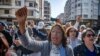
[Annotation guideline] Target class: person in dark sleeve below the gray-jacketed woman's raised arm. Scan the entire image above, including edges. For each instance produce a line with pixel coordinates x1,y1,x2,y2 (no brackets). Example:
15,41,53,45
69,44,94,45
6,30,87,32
14,39,41,56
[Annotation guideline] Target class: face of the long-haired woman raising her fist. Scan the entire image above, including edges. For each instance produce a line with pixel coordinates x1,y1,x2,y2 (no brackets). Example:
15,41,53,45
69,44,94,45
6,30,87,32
51,26,62,45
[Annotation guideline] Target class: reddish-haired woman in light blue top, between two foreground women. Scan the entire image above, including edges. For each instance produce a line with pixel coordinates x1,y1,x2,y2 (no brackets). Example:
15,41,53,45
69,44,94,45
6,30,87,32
66,26,81,49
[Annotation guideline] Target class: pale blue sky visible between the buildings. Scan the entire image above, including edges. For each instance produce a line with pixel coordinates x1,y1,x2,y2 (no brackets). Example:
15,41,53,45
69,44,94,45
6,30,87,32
48,0,67,18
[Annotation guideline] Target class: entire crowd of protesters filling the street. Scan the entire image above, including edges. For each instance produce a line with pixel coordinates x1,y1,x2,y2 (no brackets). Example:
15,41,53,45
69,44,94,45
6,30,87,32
0,7,100,56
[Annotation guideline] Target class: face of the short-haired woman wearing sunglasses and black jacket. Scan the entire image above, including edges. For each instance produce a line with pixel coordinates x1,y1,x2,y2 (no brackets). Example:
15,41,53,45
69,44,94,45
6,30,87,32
83,31,95,44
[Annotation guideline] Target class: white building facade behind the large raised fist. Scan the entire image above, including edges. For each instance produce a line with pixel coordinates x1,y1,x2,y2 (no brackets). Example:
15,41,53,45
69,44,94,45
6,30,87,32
0,0,39,21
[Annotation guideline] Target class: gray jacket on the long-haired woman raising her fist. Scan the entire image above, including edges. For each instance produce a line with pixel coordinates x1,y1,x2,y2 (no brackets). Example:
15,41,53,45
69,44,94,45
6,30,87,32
19,30,73,56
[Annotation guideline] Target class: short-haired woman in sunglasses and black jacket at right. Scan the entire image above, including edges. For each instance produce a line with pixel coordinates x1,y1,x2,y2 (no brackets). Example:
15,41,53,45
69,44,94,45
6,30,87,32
74,28,100,56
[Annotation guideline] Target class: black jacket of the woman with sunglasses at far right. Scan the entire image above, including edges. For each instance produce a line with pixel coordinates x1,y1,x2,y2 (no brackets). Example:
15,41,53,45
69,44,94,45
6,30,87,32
74,44,100,56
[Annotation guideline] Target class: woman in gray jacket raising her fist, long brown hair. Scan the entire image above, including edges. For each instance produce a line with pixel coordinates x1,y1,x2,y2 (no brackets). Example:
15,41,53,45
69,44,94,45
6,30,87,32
16,7,73,56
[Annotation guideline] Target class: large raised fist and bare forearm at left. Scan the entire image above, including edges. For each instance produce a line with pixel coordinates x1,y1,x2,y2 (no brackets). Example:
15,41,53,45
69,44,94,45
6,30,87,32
15,6,27,33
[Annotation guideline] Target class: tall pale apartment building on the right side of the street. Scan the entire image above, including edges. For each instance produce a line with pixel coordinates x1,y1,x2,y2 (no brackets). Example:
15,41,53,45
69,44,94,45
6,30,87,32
64,0,98,26
